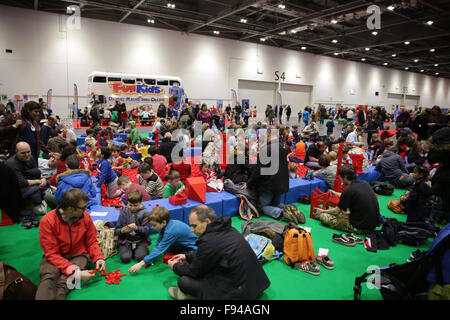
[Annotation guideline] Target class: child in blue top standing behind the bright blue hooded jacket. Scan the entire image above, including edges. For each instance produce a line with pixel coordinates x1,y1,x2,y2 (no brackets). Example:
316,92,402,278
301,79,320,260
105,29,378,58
97,147,122,199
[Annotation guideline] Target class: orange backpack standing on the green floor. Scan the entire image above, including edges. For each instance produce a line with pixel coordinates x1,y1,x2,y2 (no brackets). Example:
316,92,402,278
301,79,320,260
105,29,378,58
283,228,316,267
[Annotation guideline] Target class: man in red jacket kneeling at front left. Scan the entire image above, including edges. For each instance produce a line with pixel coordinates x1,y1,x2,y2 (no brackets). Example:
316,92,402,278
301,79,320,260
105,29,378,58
36,188,106,300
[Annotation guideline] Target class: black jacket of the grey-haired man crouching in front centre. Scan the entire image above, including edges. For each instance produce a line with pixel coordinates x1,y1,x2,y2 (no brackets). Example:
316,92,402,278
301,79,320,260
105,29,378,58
173,216,270,300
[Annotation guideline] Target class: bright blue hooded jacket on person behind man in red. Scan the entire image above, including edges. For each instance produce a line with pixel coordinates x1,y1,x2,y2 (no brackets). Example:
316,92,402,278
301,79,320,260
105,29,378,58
55,169,100,208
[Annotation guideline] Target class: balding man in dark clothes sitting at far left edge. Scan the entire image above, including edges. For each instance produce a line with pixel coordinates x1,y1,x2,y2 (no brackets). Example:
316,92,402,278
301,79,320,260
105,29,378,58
5,141,50,229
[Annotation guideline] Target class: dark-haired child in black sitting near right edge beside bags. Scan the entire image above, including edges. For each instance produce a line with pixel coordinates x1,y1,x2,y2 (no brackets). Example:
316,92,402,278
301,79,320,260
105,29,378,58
401,166,431,222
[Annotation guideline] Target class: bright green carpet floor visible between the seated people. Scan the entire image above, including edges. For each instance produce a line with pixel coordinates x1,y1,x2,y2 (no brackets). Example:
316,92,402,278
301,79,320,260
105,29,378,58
0,190,438,300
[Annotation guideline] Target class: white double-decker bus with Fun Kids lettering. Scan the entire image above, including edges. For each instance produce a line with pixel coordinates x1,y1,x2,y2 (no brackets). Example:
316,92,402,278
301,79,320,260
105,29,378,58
88,72,184,109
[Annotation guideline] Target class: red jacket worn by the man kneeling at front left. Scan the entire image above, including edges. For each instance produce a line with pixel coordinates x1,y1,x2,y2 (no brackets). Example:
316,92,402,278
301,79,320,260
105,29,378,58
39,208,103,276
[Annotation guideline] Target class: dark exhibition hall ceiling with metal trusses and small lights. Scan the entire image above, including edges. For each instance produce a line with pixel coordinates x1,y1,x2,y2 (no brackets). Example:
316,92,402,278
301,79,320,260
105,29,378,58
2,0,450,78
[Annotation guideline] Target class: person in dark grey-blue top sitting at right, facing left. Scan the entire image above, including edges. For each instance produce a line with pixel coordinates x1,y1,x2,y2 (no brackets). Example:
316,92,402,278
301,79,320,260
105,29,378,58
375,141,414,189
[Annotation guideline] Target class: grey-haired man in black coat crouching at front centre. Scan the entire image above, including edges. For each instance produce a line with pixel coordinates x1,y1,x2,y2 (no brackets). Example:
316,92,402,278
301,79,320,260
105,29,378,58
168,205,270,300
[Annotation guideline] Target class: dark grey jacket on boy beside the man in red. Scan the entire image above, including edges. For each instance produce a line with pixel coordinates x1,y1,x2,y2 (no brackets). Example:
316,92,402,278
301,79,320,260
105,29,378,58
114,206,152,245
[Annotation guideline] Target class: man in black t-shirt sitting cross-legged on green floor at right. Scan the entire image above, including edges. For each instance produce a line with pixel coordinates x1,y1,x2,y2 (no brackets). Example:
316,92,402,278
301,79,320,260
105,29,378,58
314,165,380,234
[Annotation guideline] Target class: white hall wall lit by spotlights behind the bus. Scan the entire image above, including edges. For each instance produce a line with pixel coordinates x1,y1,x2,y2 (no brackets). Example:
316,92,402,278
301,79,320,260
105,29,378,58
0,6,450,115
